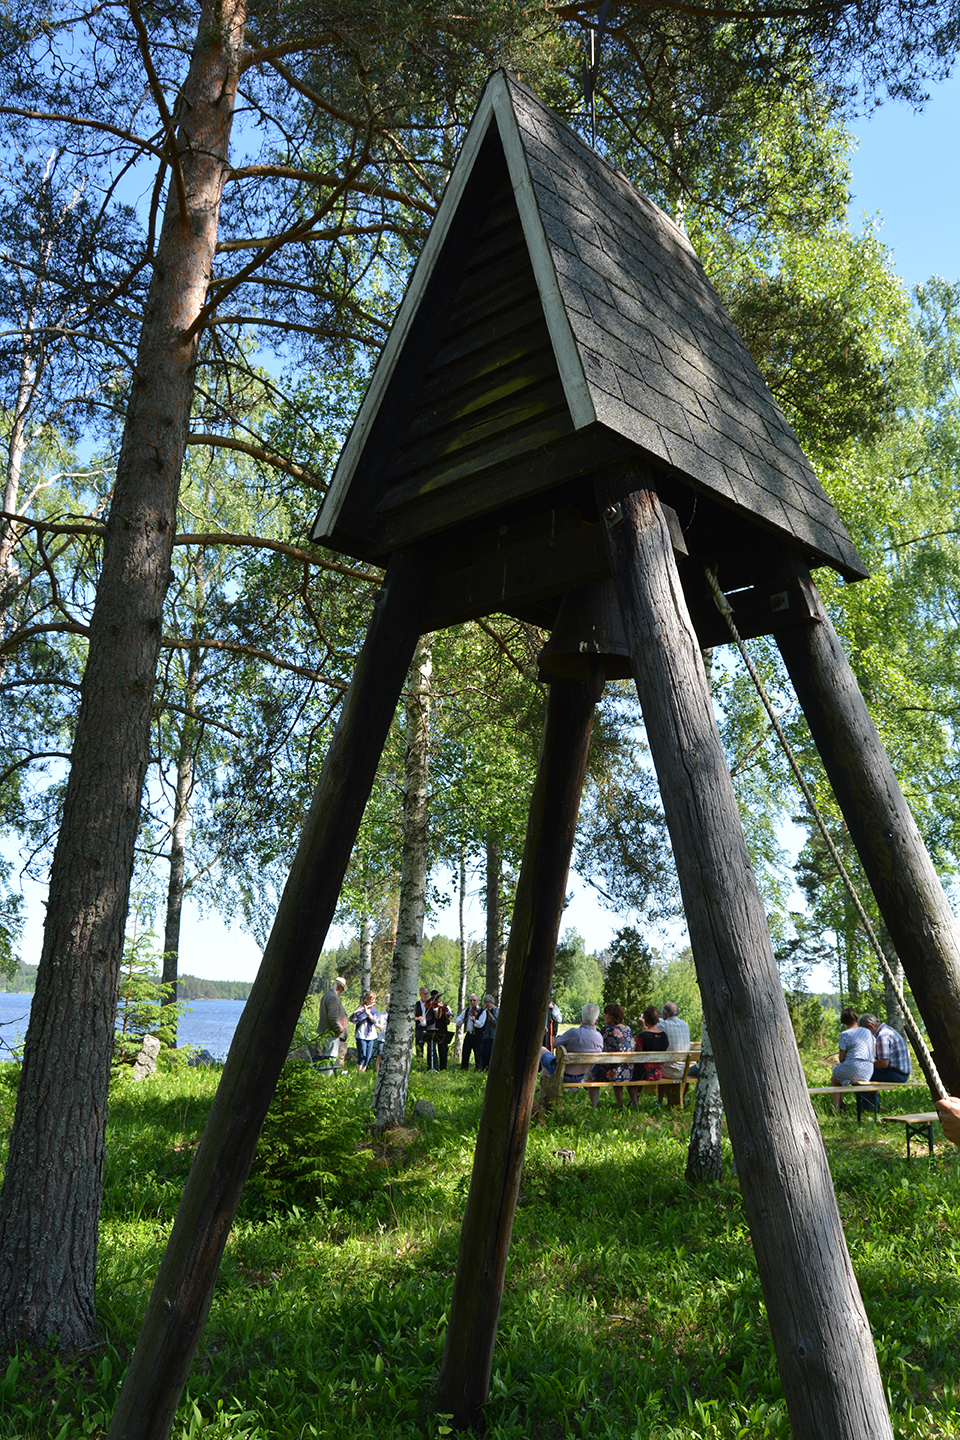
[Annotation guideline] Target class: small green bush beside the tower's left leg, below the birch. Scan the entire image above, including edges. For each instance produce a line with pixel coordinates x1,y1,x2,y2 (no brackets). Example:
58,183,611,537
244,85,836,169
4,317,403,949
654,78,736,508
243,1060,371,1218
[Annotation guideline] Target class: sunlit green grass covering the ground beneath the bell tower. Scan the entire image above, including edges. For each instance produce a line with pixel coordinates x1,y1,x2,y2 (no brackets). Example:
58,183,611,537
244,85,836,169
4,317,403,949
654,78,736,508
0,1070,960,1440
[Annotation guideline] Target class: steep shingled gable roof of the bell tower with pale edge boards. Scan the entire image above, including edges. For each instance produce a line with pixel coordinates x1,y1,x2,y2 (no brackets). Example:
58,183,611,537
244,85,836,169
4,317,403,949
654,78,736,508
312,72,866,579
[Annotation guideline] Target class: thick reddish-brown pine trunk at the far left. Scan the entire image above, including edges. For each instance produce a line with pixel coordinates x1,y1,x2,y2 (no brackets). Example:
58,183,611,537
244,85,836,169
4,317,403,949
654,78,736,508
0,0,245,1351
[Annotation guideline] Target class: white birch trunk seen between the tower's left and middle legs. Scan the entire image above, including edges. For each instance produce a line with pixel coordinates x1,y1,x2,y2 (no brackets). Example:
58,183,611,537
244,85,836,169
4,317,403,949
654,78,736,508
373,635,433,1130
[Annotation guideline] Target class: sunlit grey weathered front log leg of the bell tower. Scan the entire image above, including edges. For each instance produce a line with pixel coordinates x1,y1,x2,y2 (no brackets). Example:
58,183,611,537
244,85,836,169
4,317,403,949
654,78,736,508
596,465,891,1440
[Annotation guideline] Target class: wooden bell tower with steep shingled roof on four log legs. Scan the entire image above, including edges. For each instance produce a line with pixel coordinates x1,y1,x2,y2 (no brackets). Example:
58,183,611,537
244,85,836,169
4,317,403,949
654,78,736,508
109,72,960,1440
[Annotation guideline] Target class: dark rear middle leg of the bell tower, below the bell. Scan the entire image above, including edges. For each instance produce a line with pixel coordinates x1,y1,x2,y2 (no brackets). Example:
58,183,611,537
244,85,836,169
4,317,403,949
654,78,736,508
436,680,596,1420
